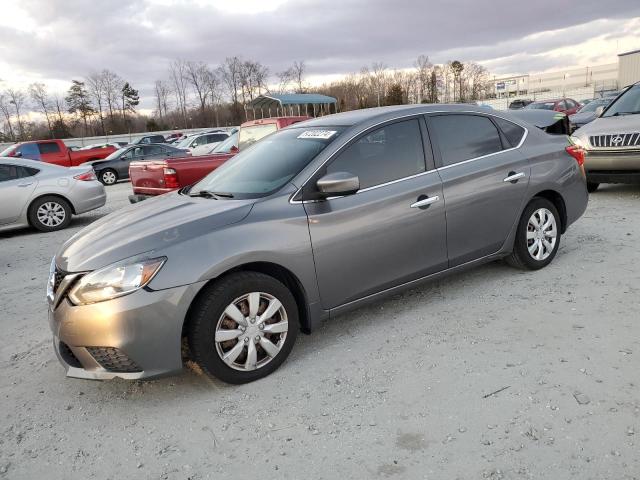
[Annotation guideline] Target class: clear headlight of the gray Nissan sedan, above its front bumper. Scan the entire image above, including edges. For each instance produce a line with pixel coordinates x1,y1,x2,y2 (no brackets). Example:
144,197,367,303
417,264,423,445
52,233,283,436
69,257,167,305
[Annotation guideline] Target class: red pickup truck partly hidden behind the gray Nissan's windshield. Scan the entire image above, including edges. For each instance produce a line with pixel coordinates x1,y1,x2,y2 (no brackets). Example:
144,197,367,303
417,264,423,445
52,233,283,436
129,117,310,203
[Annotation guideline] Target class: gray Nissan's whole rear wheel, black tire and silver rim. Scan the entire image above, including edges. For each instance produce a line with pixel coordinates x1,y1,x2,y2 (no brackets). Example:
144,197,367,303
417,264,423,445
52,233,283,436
506,197,562,270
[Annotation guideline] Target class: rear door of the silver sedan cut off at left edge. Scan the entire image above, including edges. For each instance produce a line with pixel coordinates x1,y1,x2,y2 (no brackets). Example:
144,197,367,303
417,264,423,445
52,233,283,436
0,162,38,225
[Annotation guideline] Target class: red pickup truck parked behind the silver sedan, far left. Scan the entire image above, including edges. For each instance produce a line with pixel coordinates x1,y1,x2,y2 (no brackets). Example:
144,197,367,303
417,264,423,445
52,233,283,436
0,140,116,167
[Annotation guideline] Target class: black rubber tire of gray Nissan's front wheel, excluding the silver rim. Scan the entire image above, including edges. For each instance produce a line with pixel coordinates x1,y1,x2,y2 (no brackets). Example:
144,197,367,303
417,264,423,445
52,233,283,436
187,272,300,384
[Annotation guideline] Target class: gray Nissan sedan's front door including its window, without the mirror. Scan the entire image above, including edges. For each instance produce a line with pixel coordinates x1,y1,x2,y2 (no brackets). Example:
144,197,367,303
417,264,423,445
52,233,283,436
304,118,447,309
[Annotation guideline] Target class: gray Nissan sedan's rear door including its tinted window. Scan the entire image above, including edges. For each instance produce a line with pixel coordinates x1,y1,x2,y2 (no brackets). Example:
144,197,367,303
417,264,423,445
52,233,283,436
427,113,531,267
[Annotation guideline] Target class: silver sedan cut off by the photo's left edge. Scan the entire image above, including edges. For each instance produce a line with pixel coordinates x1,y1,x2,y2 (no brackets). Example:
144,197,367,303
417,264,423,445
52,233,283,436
0,157,107,232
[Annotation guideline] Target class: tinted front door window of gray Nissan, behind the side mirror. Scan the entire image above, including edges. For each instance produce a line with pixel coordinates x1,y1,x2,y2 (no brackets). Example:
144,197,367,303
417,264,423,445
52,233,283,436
327,119,426,188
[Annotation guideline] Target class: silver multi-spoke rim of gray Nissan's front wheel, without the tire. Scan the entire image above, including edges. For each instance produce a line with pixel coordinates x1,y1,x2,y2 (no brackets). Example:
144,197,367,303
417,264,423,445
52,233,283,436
215,292,289,371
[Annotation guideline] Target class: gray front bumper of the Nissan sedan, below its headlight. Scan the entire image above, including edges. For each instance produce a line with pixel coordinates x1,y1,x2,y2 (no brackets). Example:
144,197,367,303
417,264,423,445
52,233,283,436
49,283,203,380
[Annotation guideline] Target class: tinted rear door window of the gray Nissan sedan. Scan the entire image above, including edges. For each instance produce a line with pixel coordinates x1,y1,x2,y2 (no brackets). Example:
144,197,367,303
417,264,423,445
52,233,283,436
429,115,502,167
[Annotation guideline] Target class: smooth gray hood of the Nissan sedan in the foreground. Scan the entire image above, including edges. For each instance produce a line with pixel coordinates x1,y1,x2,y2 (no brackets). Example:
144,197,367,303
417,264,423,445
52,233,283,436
56,192,255,272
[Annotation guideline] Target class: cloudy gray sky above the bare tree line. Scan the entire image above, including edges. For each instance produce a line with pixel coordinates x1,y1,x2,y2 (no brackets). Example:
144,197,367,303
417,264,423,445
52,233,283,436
0,0,640,106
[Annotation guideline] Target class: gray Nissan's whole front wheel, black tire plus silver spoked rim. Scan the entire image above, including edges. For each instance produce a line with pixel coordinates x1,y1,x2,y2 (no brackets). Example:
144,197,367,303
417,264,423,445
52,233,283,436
186,272,300,384
